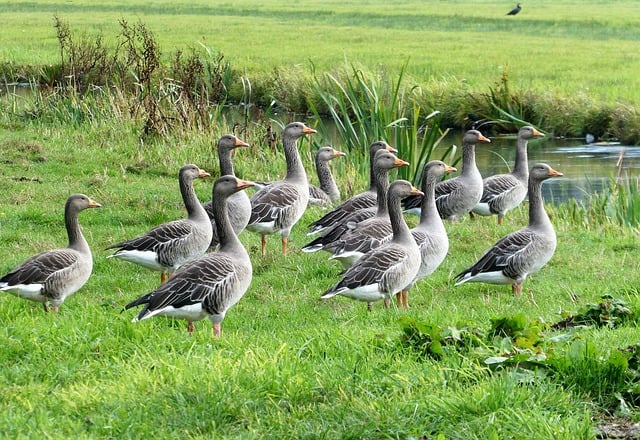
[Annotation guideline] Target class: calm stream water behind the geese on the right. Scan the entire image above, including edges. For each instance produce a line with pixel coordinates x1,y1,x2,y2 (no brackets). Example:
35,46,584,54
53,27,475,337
458,134,640,204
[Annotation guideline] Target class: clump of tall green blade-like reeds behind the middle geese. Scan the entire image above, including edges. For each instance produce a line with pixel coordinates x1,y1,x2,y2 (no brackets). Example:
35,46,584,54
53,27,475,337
310,66,455,184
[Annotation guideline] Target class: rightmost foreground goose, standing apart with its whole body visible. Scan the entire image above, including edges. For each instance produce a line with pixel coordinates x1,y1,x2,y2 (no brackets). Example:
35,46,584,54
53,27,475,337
455,163,562,295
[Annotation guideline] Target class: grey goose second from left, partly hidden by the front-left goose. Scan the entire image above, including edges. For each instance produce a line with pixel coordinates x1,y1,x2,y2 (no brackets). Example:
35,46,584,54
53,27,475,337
107,164,213,283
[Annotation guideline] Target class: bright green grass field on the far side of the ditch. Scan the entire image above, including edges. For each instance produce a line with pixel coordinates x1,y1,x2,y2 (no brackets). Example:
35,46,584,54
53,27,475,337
0,0,640,104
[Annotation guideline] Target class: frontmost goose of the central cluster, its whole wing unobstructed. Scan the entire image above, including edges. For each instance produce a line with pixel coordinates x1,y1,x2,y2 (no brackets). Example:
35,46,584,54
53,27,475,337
321,180,422,306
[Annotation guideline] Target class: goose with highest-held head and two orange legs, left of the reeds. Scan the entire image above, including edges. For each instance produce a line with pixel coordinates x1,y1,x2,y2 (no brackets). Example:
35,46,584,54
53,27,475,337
247,122,316,256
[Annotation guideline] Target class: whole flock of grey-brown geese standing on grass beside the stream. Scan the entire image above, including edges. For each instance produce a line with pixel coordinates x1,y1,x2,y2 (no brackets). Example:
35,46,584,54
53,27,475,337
0,122,562,336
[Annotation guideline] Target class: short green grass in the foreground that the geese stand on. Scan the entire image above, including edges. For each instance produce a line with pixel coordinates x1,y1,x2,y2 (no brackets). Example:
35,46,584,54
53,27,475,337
0,118,640,439
